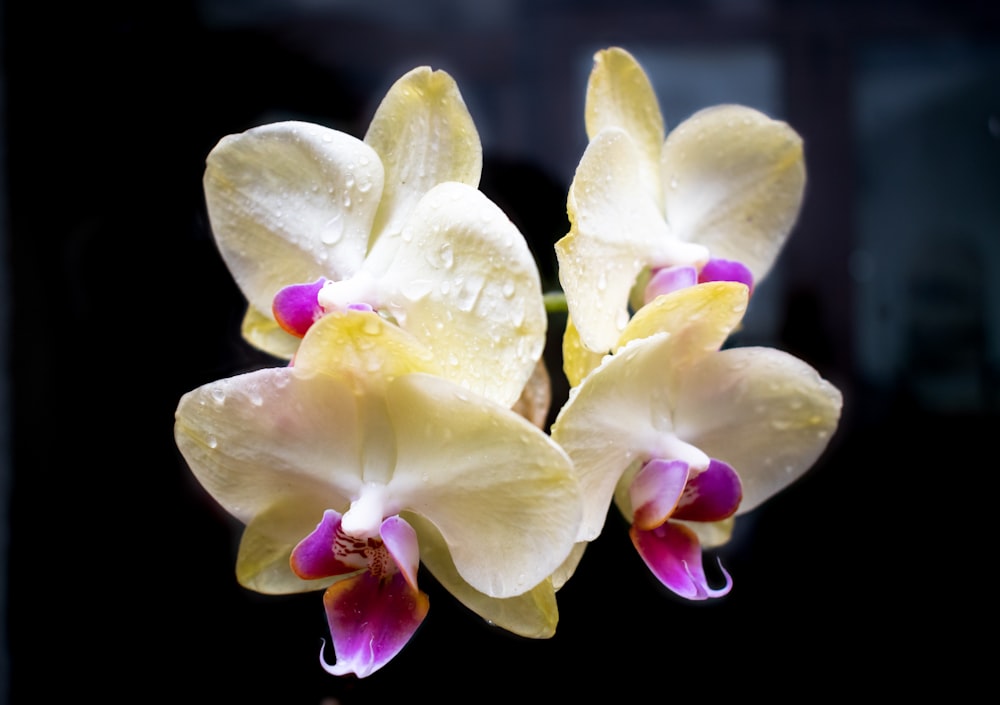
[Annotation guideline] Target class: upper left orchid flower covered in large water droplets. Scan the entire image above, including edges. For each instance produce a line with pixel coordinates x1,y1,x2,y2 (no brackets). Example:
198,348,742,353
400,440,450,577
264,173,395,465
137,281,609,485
204,67,547,406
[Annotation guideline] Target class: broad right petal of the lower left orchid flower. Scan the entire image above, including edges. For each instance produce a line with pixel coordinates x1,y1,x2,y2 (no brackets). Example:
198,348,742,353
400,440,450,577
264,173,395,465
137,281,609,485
387,374,580,597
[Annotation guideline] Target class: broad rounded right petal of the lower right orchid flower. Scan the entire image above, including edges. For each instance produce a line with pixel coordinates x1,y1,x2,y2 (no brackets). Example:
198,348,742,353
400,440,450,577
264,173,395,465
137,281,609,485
674,348,842,514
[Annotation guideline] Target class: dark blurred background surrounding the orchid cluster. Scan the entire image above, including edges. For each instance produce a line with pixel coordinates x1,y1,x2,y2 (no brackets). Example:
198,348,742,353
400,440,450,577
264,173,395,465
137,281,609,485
0,0,1000,705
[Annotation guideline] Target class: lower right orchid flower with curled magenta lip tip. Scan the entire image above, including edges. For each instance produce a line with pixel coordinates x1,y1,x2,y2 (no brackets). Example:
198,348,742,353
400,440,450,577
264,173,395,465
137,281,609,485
552,281,842,599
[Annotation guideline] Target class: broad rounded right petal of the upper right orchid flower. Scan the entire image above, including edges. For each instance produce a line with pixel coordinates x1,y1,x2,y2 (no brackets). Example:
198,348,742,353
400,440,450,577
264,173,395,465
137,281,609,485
662,105,806,281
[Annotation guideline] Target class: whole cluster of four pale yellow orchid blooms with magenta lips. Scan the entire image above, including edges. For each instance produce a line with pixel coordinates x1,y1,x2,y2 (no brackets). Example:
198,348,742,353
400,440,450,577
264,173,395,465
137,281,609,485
175,48,841,677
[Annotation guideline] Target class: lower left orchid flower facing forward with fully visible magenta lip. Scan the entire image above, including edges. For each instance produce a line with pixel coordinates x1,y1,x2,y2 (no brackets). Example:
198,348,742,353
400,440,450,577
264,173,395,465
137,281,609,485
175,310,581,677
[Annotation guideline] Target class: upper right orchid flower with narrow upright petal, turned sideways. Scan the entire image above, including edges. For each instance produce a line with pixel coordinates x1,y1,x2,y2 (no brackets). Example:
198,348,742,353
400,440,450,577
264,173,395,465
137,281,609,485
556,48,805,367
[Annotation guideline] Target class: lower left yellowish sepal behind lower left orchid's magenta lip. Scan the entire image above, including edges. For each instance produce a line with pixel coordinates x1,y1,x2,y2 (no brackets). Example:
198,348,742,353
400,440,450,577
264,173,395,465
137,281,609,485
236,494,344,595
